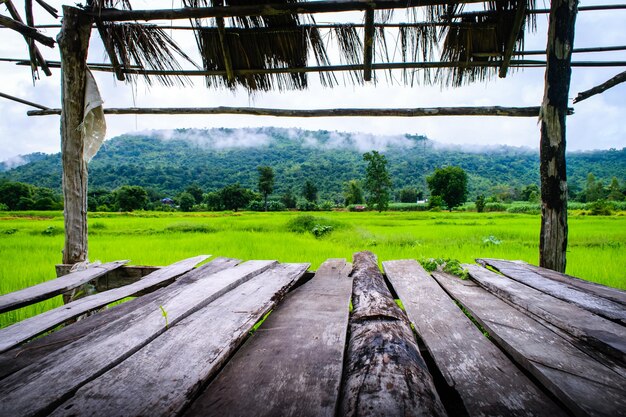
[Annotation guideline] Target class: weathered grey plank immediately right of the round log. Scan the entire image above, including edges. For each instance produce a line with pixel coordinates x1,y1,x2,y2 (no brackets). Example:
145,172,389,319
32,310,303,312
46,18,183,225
383,260,565,416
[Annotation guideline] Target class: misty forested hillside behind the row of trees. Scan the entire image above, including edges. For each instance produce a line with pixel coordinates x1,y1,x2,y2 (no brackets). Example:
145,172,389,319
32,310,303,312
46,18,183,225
0,128,626,198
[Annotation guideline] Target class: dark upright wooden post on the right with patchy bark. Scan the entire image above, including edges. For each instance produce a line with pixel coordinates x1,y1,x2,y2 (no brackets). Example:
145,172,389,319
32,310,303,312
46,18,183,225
539,0,578,272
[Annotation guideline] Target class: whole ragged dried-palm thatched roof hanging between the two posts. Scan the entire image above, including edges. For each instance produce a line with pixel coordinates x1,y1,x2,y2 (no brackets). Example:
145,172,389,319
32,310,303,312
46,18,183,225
7,0,534,91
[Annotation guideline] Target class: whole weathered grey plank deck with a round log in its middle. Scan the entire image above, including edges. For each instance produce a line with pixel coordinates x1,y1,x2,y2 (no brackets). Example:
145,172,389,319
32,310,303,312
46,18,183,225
0,252,626,417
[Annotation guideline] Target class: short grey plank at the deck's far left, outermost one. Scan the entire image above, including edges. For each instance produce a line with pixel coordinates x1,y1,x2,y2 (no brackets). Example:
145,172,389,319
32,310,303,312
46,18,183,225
0,261,128,313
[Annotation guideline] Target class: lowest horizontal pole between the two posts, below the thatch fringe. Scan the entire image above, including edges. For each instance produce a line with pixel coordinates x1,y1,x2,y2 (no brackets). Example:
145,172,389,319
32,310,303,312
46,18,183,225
27,106,574,117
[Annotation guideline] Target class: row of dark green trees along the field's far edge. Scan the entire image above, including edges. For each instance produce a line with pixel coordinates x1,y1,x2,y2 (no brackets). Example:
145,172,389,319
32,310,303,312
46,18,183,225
0,151,626,212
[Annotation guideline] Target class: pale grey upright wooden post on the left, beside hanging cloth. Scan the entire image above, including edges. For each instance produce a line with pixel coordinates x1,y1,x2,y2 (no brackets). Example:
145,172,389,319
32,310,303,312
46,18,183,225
57,6,91,264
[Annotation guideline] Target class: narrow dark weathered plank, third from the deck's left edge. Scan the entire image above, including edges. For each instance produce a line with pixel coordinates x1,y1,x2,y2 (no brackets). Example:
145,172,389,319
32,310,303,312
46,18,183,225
0,258,240,379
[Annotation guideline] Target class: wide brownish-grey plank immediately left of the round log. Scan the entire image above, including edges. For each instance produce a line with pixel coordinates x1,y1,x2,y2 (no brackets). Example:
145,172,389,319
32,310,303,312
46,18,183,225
185,259,352,417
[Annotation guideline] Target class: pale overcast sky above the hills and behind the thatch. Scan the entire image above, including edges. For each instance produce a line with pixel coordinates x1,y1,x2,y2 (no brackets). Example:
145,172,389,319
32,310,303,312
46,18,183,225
0,0,626,161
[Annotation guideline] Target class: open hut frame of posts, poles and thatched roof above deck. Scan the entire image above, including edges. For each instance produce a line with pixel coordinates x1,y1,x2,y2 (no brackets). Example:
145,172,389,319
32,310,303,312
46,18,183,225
0,0,626,271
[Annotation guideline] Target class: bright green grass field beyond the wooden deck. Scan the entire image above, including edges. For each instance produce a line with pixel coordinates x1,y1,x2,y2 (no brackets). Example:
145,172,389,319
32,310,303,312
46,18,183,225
0,212,626,327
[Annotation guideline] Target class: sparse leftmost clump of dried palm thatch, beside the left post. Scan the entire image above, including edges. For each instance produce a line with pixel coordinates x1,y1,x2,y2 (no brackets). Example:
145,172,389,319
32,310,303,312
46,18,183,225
101,23,195,86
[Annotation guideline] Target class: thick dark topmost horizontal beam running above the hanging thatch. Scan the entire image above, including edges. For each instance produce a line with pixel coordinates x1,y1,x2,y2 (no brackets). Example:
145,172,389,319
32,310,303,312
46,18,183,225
84,0,482,22
